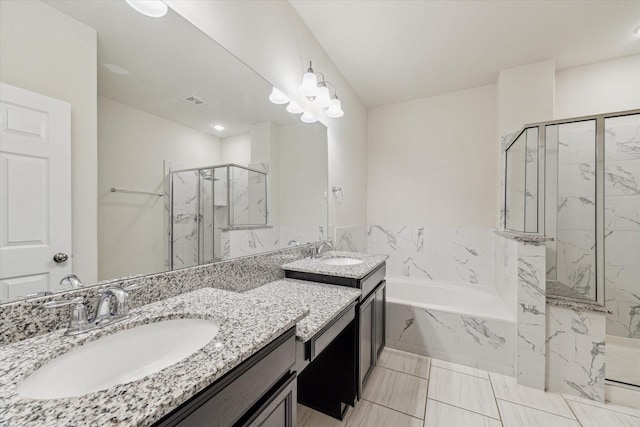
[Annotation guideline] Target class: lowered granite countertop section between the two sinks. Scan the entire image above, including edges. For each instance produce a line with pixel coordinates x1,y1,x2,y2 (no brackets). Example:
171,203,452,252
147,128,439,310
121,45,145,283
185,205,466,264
243,279,362,341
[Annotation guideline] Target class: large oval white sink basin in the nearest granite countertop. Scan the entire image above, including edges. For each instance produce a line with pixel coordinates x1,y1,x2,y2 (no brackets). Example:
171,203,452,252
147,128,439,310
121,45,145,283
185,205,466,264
17,319,220,399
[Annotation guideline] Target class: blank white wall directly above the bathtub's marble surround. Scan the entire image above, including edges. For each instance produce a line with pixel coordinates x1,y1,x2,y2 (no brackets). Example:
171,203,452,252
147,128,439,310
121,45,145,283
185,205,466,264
368,85,498,227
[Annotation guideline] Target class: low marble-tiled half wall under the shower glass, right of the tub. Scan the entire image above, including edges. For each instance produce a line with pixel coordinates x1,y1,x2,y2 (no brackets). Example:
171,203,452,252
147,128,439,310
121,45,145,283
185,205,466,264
546,304,606,402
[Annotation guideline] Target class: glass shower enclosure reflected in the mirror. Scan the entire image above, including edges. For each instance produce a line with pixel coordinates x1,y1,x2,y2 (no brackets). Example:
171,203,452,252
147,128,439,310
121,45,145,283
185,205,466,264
169,164,269,270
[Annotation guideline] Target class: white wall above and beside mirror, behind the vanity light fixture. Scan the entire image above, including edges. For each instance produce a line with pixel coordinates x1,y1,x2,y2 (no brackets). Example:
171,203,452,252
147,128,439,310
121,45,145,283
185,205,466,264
167,0,367,237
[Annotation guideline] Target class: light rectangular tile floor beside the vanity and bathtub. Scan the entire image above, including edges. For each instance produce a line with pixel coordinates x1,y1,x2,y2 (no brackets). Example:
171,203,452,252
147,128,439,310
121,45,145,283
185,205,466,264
298,348,640,427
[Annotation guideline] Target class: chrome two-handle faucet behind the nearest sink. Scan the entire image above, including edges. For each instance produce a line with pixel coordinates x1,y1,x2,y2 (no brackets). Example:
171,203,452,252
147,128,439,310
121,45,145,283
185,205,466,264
44,283,146,335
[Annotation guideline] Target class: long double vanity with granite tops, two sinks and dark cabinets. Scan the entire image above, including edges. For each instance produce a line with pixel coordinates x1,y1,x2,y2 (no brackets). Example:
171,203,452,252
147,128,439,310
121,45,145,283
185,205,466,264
0,252,386,426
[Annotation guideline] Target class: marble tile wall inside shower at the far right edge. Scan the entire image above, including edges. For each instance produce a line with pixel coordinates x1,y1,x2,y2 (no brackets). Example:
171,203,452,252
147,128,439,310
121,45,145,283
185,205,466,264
605,114,640,339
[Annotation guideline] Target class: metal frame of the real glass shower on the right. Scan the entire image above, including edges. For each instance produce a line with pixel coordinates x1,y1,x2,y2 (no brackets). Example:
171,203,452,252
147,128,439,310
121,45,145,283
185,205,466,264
502,109,640,307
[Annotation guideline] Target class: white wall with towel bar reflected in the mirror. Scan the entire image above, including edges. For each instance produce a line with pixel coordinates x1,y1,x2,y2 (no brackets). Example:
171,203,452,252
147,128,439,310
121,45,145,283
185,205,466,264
98,97,222,280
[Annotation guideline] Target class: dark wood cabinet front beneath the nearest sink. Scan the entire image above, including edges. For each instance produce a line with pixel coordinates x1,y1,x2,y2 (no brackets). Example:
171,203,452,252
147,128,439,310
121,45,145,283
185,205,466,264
154,327,296,427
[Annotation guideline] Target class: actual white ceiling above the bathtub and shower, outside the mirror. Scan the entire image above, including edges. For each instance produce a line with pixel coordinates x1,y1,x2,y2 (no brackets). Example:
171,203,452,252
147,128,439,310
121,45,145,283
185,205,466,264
290,0,640,107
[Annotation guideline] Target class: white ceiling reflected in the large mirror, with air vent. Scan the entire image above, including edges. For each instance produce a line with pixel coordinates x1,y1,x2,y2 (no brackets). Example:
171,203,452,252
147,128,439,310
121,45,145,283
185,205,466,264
48,0,299,138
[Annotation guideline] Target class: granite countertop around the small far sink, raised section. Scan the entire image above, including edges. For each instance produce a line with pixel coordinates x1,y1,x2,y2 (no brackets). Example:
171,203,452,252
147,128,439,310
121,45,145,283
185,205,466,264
282,251,389,279
